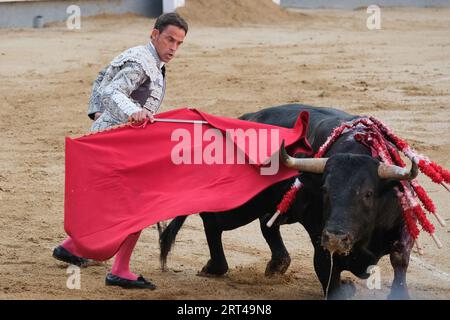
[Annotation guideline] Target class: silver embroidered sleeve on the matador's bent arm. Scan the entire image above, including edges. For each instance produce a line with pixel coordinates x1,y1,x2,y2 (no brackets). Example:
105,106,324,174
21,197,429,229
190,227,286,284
101,62,147,118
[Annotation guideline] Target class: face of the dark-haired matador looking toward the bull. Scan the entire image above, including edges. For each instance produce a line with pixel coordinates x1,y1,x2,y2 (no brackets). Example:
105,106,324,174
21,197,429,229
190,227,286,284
152,25,186,63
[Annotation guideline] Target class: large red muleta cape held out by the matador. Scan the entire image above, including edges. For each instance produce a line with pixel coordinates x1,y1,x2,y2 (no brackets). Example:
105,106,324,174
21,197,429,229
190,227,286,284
64,109,312,261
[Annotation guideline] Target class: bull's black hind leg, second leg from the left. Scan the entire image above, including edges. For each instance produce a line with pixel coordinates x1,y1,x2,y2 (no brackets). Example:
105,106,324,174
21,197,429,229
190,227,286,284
259,217,291,277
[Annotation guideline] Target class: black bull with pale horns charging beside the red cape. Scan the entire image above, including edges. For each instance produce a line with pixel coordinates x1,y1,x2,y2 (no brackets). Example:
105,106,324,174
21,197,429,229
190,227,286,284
160,105,413,299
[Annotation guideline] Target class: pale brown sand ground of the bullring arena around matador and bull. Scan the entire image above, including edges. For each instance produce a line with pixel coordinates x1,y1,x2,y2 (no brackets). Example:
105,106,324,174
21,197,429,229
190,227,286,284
0,8,450,299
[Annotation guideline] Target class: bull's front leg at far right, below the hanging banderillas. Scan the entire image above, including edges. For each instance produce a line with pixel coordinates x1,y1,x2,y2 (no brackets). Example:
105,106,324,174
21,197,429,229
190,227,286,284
388,228,414,300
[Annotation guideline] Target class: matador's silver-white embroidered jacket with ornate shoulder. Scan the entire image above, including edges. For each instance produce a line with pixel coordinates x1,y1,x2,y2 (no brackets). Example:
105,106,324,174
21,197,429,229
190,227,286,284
88,43,166,131
